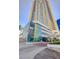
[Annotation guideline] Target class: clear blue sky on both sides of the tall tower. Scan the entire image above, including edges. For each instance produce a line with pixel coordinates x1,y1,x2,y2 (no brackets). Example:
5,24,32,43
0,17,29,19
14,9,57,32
19,0,60,26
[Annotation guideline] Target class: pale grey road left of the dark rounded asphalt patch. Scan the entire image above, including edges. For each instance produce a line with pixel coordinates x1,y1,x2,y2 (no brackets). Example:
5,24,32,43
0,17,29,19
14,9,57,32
19,42,46,59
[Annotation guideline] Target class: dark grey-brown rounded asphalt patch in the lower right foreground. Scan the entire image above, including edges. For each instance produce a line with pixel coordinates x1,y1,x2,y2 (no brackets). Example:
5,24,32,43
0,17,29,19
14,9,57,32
34,48,60,59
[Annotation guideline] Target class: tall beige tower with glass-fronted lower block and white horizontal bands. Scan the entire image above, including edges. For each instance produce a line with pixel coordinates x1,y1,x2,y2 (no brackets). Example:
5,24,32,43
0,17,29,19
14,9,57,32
27,0,58,42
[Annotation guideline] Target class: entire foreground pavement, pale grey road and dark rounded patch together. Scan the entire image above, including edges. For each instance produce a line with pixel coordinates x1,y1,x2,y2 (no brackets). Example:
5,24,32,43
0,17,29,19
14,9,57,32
19,44,60,59
